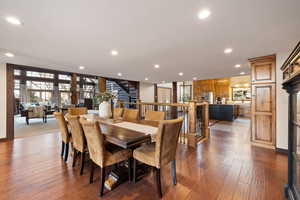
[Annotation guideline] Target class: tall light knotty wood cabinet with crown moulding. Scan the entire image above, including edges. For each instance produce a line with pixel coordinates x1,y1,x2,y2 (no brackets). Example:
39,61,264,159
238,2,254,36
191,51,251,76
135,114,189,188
249,55,276,149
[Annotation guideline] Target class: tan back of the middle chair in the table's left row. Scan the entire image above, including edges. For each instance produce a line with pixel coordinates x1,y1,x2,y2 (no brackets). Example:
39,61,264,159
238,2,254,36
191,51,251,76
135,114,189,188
65,115,86,152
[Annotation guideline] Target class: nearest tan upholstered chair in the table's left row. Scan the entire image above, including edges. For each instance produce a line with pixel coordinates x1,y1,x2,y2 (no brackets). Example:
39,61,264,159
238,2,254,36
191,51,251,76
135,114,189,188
80,117,132,196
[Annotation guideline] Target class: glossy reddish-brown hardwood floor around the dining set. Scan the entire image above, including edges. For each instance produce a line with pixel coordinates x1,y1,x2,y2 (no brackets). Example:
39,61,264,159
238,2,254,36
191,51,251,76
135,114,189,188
0,119,287,200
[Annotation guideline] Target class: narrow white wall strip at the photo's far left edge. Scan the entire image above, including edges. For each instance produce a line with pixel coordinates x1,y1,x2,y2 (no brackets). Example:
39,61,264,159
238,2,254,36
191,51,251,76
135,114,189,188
0,63,6,138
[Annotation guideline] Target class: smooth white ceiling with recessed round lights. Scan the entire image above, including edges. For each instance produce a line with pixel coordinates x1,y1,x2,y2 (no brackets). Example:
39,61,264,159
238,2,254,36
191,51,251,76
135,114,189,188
0,0,300,82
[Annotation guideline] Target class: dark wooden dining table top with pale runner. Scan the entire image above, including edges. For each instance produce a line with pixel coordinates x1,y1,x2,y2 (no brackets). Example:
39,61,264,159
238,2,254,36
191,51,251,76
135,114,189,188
82,114,159,149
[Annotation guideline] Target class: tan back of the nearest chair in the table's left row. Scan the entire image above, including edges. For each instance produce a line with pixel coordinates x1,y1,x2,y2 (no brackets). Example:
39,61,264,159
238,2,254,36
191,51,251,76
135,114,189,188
80,117,105,167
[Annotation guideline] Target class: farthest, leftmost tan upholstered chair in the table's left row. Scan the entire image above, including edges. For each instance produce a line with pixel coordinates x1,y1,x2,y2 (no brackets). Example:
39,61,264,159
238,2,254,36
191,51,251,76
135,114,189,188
53,112,71,162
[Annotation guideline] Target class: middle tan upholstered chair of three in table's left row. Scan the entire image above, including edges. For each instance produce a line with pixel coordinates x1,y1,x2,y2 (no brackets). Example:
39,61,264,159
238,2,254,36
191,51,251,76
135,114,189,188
65,115,88,175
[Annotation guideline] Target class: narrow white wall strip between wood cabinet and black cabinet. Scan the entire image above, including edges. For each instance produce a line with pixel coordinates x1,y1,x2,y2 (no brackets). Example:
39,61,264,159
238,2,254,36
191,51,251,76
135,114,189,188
276,52,290,149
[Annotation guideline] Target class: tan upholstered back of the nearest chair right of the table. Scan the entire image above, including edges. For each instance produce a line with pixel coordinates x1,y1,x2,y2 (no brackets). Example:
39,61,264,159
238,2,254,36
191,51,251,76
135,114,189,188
155,117,183,168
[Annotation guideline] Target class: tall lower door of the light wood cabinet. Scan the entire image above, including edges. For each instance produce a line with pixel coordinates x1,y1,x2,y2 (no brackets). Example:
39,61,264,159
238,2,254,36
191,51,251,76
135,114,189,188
251,84,276,147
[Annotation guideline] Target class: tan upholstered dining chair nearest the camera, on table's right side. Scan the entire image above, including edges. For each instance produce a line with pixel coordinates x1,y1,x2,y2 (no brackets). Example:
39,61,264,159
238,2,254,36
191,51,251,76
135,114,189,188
133,117,183,198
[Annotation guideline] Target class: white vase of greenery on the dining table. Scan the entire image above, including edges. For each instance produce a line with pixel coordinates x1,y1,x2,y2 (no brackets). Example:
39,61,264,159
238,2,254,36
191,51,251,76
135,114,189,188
97,92,116,119
